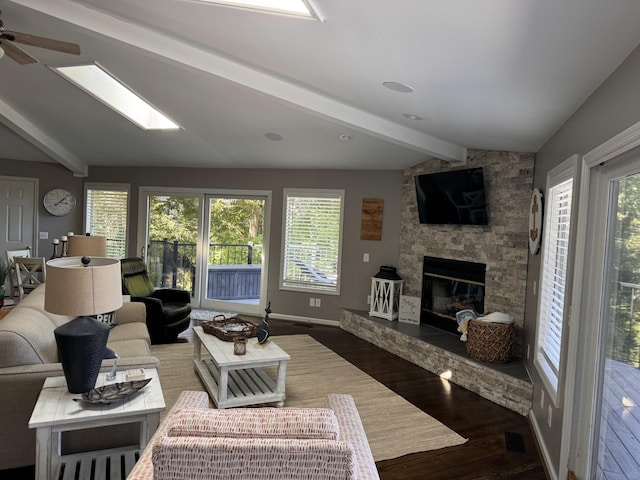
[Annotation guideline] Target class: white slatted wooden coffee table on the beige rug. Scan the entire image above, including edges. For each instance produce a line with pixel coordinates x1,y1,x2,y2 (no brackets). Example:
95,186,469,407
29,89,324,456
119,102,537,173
193,327,291,408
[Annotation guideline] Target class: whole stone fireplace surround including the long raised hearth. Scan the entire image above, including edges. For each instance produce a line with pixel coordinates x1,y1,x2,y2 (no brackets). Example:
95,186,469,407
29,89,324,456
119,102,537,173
340,150,535,415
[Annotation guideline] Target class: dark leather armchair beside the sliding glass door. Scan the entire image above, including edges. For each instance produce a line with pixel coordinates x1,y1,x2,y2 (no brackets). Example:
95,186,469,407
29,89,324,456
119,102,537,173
120,258,191,343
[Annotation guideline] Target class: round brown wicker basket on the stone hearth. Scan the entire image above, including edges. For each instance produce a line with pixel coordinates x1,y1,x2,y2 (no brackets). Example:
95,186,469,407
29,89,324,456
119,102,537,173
467,320,513,363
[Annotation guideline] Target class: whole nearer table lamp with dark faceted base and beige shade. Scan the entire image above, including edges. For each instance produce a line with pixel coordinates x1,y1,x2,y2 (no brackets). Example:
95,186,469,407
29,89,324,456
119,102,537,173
44,256,122,393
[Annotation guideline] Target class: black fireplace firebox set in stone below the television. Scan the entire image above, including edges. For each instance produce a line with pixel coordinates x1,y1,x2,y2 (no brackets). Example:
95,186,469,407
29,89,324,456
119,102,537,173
420,256,486,333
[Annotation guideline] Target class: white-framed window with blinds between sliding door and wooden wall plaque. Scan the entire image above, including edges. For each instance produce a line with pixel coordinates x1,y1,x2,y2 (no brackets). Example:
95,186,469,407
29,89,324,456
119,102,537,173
280,189,344,295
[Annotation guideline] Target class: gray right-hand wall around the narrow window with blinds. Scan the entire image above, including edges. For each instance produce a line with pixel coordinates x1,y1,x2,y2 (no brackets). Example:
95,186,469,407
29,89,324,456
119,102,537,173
524,42,640,476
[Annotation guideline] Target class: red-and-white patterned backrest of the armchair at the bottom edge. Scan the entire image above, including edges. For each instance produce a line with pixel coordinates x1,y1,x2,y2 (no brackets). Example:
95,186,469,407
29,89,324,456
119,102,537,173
152,437,358,480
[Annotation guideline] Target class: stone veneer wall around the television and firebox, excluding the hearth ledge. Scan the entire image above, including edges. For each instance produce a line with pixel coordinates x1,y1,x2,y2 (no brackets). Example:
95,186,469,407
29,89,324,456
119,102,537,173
398,150,535,357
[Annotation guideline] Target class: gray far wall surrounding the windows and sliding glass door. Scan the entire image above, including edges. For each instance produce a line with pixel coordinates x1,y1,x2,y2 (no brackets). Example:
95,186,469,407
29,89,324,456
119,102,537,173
0,160,403,320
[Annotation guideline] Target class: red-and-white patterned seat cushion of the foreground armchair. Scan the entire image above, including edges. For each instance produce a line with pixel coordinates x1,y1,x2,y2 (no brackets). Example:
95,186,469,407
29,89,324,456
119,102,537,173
168,407,340,440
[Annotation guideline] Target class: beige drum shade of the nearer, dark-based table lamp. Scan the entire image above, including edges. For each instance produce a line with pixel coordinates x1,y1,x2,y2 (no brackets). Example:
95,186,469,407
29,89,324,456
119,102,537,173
44,257,122,315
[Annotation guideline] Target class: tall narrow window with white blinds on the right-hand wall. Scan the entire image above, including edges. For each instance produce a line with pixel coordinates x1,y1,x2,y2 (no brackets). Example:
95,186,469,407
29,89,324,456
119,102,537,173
536,159,575,404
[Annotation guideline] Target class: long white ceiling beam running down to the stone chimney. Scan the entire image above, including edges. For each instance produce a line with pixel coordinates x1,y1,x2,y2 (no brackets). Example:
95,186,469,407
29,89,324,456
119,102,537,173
12,0,466,162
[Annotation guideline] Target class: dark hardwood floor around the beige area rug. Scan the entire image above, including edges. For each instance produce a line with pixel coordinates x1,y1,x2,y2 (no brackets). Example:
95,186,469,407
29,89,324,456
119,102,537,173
0,320,548,480
